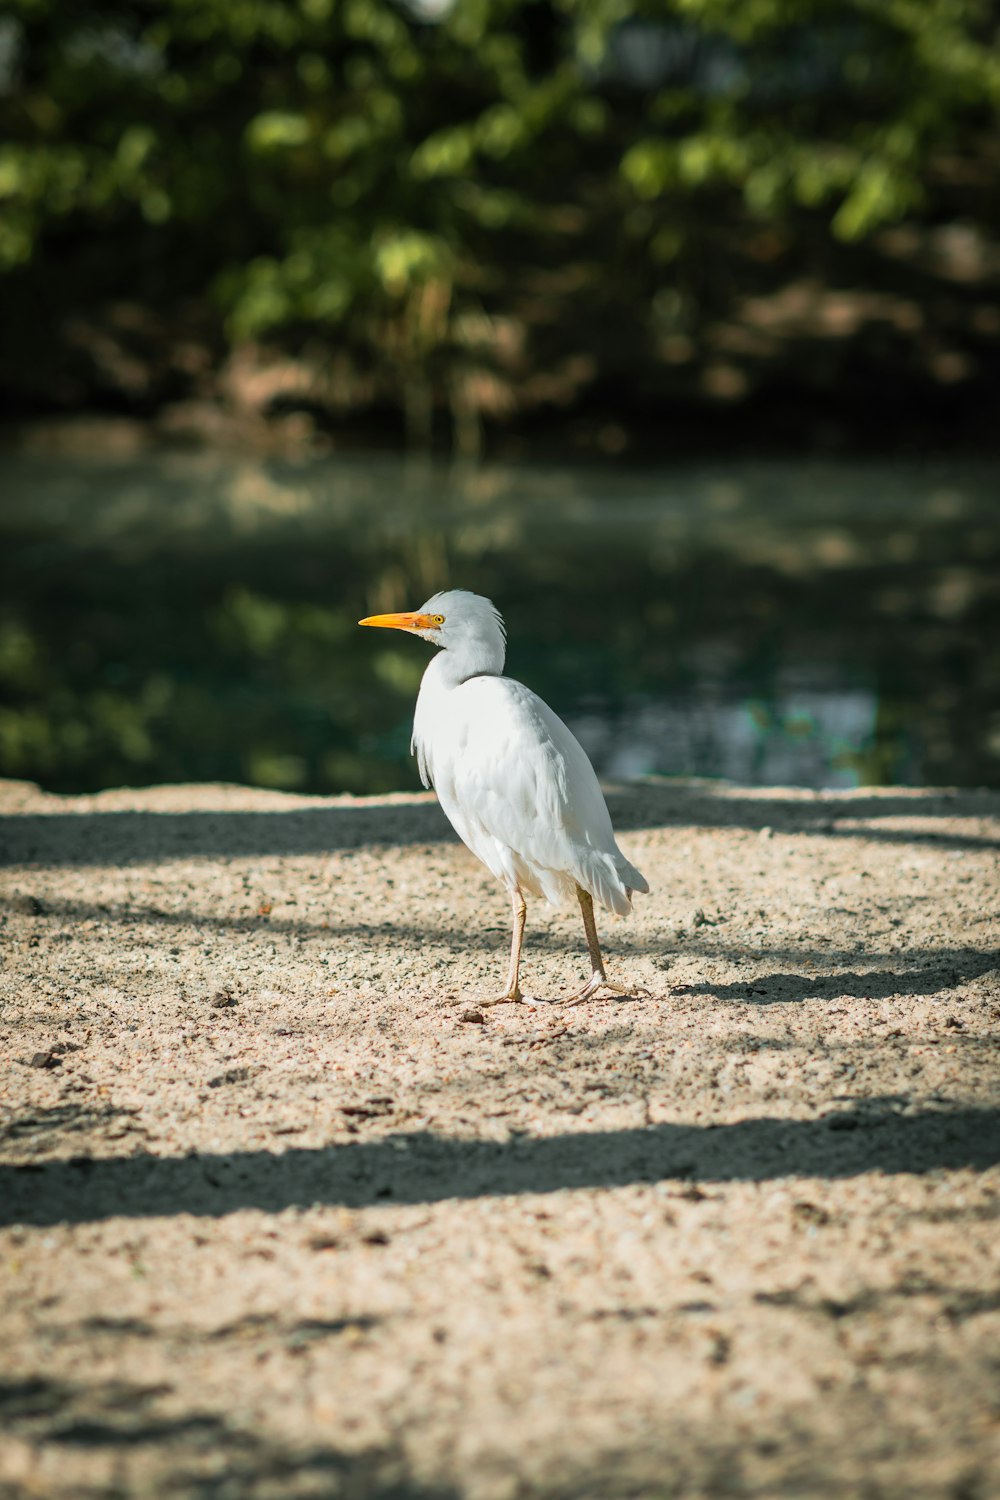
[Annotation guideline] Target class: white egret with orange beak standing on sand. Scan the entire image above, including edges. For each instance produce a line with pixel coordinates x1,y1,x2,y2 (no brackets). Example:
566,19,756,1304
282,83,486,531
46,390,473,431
358,588,649,1005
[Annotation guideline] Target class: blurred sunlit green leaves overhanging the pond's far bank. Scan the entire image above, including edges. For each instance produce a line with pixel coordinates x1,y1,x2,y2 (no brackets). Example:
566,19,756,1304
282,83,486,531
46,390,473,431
0,0,1000,423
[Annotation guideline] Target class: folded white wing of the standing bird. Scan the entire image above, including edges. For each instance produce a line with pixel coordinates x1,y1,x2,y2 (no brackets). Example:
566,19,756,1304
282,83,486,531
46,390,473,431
432,677,646,912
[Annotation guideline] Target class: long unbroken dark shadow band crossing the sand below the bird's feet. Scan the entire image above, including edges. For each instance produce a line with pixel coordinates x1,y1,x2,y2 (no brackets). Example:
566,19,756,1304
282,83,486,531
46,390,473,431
0,1100,1000,1224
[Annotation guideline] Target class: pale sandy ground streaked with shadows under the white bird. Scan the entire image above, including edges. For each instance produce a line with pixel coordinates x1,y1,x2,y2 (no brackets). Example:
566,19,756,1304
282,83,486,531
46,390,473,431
0,783,1000,1500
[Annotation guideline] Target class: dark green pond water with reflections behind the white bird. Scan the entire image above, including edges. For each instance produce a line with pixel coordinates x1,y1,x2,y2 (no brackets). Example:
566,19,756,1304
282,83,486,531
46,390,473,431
0,455,1000,792
